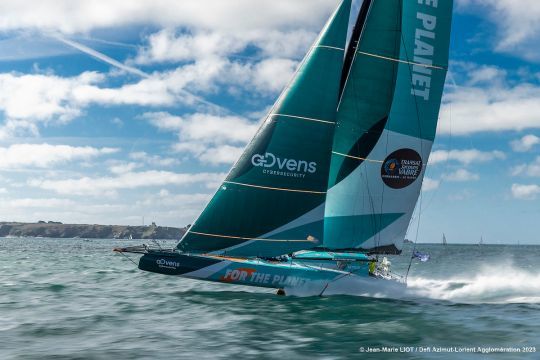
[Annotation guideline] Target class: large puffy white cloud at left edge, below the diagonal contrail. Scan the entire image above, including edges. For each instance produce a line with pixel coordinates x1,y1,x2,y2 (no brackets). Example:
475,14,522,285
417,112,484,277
0,62,234,138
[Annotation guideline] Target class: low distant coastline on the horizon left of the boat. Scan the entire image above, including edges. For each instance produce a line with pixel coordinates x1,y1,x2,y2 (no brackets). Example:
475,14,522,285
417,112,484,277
0,221,187,240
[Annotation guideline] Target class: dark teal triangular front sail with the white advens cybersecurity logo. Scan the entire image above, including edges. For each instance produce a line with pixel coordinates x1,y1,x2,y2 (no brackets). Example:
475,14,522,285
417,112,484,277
178,0,351,257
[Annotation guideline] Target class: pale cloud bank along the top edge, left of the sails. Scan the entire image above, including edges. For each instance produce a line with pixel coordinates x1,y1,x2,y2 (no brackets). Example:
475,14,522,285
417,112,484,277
0,0,337,34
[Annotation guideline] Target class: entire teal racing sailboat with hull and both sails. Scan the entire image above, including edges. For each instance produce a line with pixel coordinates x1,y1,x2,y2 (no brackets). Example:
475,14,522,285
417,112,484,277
115,0,452,295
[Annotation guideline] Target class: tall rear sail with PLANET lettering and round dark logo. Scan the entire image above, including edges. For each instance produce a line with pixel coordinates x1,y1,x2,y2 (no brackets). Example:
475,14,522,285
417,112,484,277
323,0,452,253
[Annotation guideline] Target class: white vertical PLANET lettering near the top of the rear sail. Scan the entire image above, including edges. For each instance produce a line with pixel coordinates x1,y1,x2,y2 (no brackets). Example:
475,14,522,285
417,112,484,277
411,0,439,101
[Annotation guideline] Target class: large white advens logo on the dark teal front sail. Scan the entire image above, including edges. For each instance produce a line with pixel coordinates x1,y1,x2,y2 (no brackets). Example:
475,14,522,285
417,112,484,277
251,153,317,178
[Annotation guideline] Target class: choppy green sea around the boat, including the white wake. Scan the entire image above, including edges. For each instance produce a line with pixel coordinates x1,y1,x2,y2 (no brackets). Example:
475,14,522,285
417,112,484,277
0,238,540,360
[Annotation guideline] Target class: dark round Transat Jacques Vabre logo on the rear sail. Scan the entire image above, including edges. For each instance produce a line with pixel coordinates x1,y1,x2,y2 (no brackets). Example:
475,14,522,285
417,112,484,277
381,149,422,189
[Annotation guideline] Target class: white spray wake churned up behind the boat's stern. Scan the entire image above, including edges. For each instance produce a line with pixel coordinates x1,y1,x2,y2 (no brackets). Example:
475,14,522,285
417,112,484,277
407,265,540,304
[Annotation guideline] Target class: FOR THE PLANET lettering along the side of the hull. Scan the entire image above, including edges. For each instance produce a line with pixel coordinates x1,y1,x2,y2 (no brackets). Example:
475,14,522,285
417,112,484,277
220,268,307,287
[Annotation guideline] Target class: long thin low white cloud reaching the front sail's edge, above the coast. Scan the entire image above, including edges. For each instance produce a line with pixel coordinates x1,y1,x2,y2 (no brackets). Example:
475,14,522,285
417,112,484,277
28,171,225,196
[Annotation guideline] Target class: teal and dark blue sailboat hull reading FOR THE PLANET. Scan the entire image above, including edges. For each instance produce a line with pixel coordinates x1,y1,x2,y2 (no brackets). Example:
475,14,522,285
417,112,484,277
139,251,386,295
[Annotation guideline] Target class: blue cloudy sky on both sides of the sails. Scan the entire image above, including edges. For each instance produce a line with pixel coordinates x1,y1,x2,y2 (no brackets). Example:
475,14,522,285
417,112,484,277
0,0,540,244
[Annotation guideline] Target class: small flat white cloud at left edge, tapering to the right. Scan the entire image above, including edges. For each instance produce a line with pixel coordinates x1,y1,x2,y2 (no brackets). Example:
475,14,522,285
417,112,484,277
0,144,118,169
